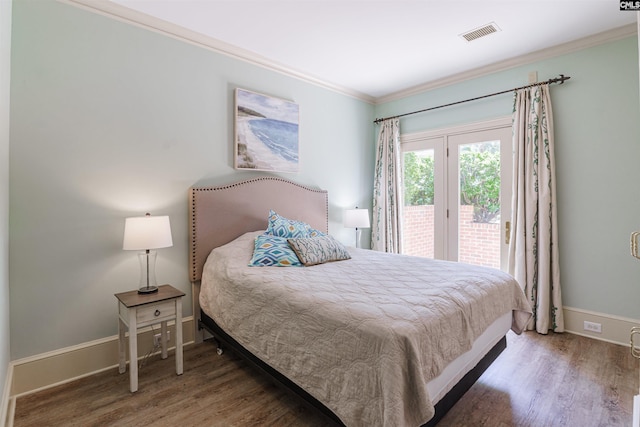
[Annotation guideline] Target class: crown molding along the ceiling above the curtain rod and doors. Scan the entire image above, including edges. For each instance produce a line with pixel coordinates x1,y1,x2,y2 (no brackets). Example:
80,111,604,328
375,24,639,104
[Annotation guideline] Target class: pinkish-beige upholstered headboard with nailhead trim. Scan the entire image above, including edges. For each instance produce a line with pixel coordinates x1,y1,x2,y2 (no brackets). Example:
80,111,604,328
189,177,329,283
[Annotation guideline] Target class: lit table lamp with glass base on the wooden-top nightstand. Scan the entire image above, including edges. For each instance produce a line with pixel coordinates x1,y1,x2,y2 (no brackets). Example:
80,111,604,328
122,213,173,294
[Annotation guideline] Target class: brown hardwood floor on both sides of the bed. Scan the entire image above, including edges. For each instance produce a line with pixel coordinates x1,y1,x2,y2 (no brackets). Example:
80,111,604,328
14,332,639,427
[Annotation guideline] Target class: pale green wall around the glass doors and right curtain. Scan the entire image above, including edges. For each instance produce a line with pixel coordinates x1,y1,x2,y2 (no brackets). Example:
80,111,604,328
376,37,640,319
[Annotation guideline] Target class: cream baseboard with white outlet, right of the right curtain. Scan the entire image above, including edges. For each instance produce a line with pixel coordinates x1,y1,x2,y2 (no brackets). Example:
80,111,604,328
563,307,640,347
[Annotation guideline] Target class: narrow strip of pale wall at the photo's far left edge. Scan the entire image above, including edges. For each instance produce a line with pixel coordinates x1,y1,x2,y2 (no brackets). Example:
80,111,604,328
0,1,11,404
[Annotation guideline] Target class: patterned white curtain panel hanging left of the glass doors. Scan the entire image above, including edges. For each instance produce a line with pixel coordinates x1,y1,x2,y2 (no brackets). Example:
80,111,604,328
371,119,402,253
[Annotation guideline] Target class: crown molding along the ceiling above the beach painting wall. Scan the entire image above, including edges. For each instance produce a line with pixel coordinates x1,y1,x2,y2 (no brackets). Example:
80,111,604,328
57,0,375,104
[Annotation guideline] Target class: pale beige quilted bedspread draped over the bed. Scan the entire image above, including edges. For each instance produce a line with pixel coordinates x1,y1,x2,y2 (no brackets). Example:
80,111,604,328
200,232,531,427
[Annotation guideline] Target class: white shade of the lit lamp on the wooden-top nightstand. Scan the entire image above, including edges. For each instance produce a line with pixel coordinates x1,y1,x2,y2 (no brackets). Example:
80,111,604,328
122,215,173,250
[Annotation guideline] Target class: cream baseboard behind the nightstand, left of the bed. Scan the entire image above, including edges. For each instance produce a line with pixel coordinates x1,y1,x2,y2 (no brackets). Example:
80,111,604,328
9,316,194,404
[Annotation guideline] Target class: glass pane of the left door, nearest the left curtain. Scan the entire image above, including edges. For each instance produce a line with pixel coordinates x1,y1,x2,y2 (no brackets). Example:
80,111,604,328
402,149,434,258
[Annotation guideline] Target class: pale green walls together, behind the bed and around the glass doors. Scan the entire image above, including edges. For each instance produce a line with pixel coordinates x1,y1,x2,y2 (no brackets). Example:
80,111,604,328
7,0,640,366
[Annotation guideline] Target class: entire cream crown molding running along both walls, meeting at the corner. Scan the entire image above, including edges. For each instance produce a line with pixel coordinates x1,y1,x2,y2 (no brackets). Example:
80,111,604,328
57,0,638,105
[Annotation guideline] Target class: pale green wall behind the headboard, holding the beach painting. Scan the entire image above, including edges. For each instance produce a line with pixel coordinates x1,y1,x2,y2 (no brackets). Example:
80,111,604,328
10,0,374,358
